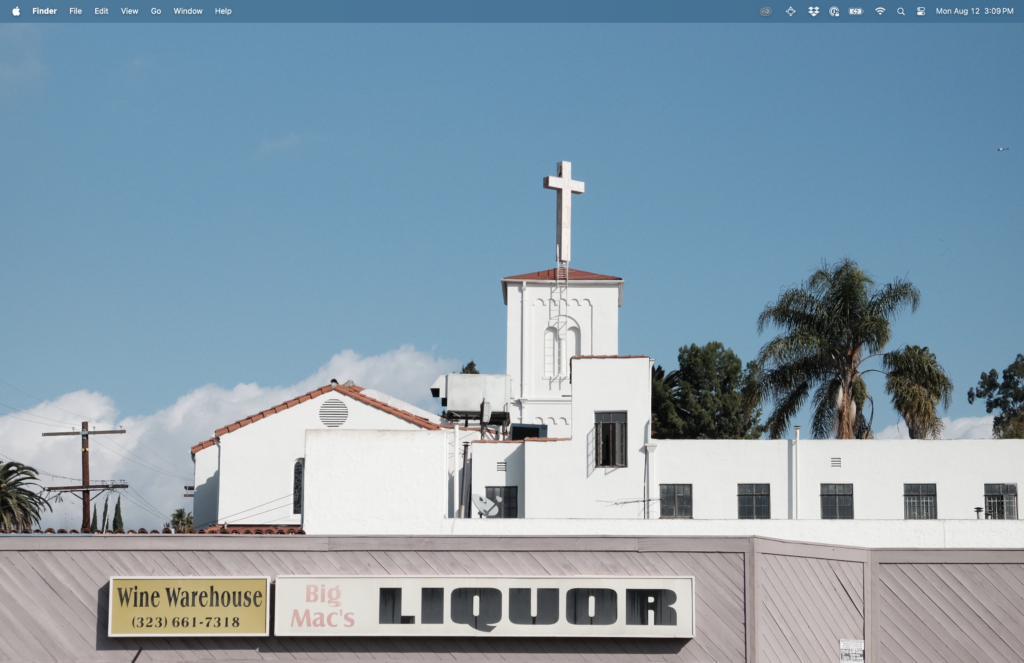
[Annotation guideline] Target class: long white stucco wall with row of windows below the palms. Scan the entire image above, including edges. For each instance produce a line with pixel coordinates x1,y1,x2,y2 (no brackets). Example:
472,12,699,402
651,440,1024,521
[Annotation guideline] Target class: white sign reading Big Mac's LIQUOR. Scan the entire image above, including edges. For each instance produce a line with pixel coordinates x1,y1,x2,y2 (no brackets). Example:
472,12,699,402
274,576,695,637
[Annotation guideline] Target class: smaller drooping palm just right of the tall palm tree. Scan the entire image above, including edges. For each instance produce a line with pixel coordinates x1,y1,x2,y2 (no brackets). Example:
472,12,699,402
882,345,953,440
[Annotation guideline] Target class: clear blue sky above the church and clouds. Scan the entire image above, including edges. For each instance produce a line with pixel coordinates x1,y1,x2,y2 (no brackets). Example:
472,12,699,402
0,25,1024,442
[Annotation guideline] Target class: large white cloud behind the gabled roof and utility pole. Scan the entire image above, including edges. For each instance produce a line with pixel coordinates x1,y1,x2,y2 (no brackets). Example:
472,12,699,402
0,345,459,529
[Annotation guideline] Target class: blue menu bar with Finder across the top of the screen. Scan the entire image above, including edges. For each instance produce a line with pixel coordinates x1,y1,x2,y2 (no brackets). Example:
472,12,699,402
0,0,1024,26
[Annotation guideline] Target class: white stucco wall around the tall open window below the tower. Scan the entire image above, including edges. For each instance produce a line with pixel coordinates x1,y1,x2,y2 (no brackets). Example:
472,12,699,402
519,358,650,519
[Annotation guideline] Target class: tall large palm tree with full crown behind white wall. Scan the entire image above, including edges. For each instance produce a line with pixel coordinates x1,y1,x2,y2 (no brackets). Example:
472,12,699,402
757,258,921,440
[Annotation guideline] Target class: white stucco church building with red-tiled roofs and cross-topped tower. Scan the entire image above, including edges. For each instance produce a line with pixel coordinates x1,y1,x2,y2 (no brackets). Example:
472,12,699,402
191,162,1024,547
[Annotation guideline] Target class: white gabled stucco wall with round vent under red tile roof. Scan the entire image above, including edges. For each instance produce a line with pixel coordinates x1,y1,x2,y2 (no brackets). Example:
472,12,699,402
214,391,421,525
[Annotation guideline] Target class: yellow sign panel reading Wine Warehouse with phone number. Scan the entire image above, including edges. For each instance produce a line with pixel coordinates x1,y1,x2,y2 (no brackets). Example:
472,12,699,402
108,576,270,637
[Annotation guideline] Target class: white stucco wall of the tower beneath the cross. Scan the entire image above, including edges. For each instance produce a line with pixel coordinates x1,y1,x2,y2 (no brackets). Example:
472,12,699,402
506,281,622,438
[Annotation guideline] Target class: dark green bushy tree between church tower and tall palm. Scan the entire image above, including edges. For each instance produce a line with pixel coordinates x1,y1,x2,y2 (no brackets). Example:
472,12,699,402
651,341,766,440
